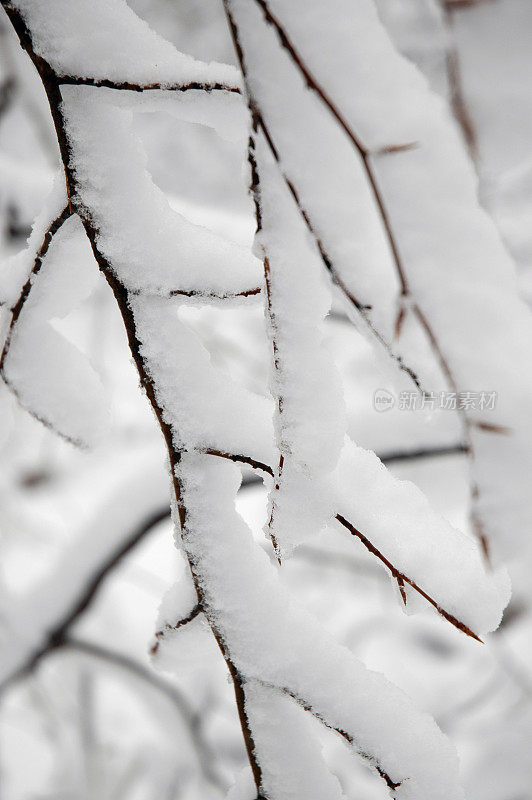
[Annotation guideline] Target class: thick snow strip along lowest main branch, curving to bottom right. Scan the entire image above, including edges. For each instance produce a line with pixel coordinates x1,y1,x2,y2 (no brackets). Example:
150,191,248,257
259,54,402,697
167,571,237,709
174,454,463,800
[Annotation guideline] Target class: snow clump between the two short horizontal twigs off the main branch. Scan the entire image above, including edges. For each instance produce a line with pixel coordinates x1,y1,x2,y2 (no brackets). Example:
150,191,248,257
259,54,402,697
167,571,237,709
63,87,262,302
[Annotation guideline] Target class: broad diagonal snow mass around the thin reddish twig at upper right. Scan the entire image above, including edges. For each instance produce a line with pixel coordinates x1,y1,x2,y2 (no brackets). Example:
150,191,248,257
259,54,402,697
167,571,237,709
225,0,532,564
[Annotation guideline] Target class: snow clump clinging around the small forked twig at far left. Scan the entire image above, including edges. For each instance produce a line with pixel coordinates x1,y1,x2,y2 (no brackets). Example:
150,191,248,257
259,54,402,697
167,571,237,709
3,202,109,447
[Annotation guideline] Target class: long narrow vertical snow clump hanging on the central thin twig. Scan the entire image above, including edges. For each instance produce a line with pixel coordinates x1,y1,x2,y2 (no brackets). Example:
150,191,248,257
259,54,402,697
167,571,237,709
256,136,346,555
